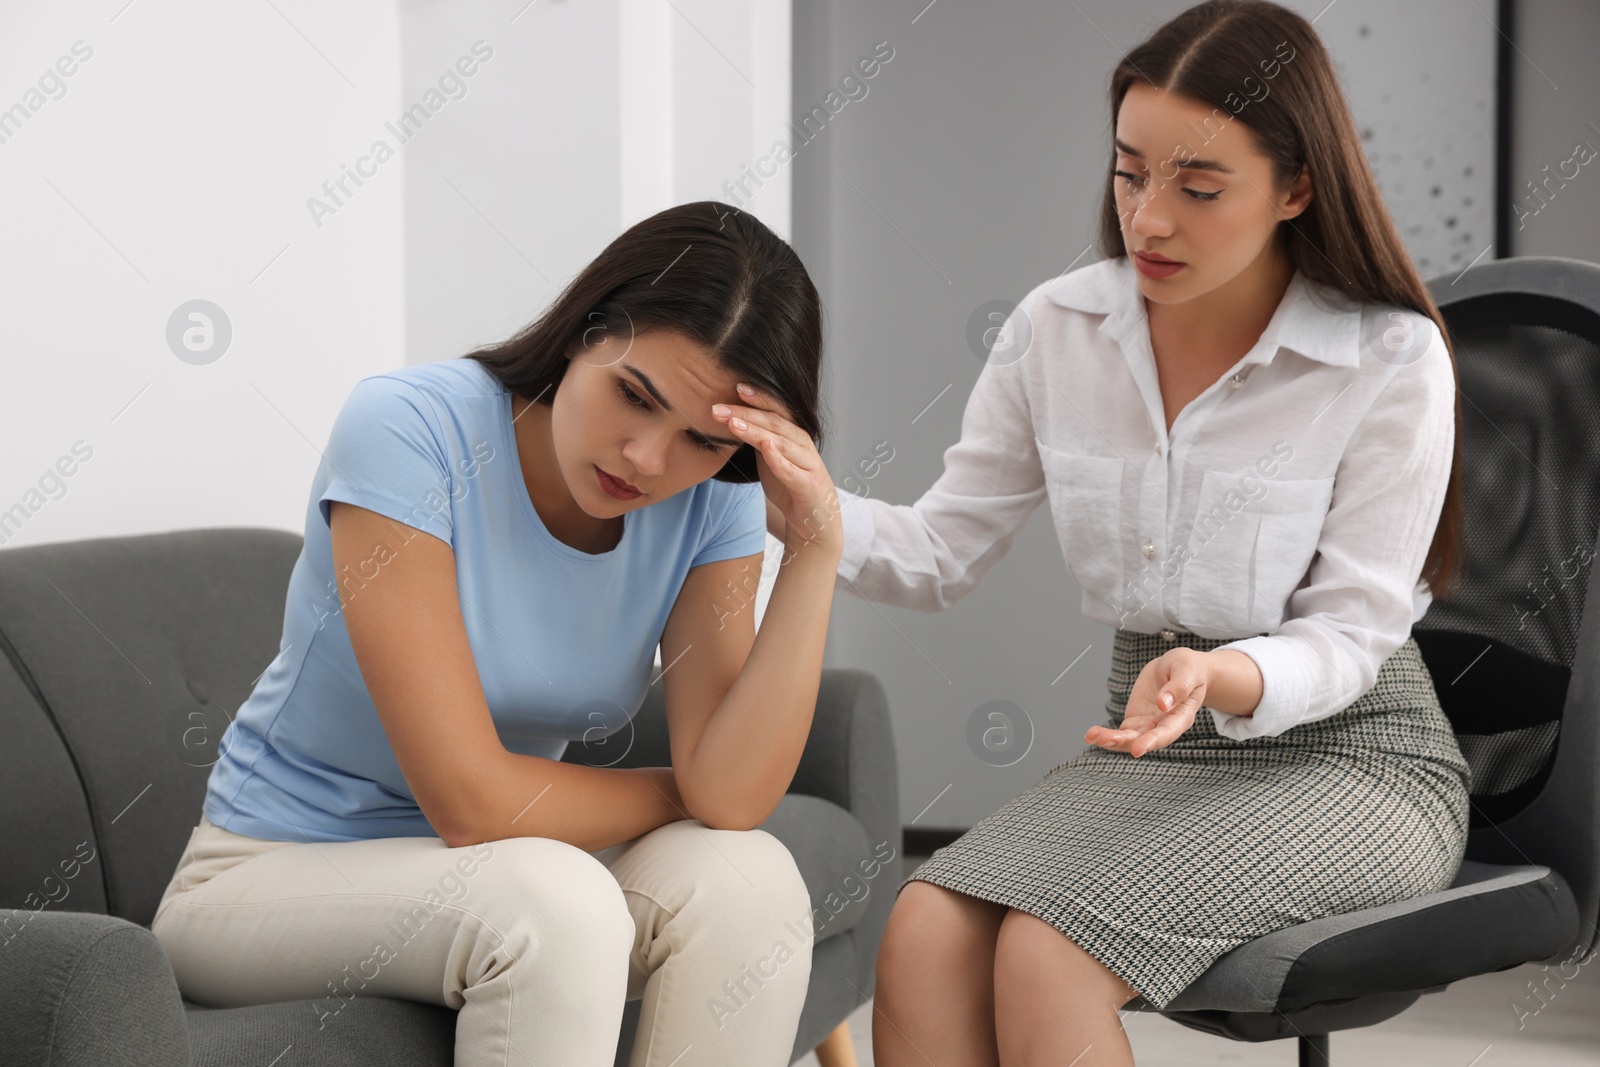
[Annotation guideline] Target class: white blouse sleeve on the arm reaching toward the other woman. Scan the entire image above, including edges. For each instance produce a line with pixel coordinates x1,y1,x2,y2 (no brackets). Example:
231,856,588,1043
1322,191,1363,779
834,301,1045,611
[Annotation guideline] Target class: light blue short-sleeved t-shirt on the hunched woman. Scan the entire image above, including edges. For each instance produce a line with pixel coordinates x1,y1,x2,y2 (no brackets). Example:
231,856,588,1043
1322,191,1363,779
203,358,766,841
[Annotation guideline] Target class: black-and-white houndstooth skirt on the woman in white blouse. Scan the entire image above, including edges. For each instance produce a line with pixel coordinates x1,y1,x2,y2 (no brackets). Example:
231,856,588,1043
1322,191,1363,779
896,630,1470,1009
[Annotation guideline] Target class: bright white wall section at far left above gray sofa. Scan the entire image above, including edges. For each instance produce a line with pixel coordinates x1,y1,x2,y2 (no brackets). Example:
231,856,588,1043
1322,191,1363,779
0,0,405,545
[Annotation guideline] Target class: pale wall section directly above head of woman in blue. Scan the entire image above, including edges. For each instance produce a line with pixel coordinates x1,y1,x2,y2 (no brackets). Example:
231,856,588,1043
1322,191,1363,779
402,0,790,633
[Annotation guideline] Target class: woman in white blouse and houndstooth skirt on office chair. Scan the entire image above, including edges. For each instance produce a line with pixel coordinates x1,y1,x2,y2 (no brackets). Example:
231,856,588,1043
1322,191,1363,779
742,2,1470,1067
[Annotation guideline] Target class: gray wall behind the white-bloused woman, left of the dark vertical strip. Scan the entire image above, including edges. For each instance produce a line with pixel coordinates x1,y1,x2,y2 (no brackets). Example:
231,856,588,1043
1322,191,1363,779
794,0,1510,829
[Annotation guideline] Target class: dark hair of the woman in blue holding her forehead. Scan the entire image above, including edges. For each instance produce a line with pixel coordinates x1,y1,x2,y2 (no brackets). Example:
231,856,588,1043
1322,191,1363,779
462,200,822,482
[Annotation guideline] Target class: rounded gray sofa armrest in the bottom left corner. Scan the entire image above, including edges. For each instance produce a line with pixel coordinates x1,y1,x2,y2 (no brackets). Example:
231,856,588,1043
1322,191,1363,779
0,909,192,1067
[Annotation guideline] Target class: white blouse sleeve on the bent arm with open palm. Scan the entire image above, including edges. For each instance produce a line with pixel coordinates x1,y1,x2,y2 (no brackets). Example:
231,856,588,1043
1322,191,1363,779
1210,315,1456,741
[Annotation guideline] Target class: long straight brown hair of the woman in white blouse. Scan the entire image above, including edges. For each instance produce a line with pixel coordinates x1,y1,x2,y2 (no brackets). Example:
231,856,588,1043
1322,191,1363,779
1099,0,1464,597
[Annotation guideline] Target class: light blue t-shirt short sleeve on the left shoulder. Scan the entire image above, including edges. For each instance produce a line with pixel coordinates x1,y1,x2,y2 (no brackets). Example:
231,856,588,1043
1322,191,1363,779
317,374,451,544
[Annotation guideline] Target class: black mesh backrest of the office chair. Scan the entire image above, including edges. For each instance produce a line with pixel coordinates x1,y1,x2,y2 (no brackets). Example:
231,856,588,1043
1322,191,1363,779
1414,293,1600,829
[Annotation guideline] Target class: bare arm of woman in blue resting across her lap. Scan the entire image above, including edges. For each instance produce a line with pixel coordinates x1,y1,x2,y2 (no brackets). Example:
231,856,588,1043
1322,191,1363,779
328,501,690,851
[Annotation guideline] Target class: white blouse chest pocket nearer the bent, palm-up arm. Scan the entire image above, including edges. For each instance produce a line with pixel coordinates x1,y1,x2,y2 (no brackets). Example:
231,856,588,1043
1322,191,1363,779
1178,470,1333,637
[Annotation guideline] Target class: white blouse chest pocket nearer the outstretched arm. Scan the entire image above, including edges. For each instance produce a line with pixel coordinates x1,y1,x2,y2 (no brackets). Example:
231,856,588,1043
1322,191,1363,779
1034,437,1125,597
